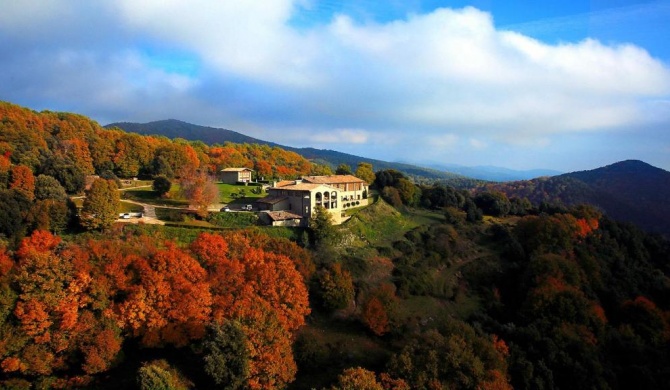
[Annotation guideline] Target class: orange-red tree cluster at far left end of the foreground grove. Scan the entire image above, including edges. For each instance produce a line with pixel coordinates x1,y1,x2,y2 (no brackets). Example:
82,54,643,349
2,231,121,375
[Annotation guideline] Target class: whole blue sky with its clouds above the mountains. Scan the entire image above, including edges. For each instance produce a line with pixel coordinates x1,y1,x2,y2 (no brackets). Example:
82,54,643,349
0,0,670,171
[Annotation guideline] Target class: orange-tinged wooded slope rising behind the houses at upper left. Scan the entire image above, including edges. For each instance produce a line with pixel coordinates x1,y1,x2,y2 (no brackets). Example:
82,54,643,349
0,102,313,186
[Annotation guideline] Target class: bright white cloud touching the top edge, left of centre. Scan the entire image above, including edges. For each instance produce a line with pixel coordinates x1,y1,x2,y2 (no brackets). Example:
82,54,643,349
117,0,316,84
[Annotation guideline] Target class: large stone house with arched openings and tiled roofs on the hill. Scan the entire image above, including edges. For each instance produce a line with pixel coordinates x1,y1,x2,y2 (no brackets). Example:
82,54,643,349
256,175,368,226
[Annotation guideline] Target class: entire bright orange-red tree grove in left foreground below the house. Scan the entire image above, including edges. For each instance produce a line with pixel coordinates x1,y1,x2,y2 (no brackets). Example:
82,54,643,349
0,225,309,389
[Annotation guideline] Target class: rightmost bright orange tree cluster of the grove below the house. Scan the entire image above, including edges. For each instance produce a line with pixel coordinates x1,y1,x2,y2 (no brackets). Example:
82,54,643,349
190,233,310,389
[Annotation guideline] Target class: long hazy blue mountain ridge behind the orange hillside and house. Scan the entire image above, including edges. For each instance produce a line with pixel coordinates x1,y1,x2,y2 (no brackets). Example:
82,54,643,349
105,119,560,185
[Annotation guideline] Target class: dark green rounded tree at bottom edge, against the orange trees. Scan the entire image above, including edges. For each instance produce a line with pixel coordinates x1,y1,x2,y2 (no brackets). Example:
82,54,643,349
203,321,249,390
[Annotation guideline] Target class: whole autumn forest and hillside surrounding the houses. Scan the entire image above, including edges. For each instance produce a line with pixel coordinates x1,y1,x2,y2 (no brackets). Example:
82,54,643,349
0,102,670,390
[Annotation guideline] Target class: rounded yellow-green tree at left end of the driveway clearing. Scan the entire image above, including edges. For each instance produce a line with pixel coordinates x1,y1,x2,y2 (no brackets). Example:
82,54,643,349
81,179,120,230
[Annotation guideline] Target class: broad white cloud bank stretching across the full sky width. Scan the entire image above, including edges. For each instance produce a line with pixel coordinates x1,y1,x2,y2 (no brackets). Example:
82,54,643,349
0,0,670,169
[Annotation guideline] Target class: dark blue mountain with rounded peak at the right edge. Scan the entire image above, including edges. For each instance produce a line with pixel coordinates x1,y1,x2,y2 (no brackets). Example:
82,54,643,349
494,160,670,237
